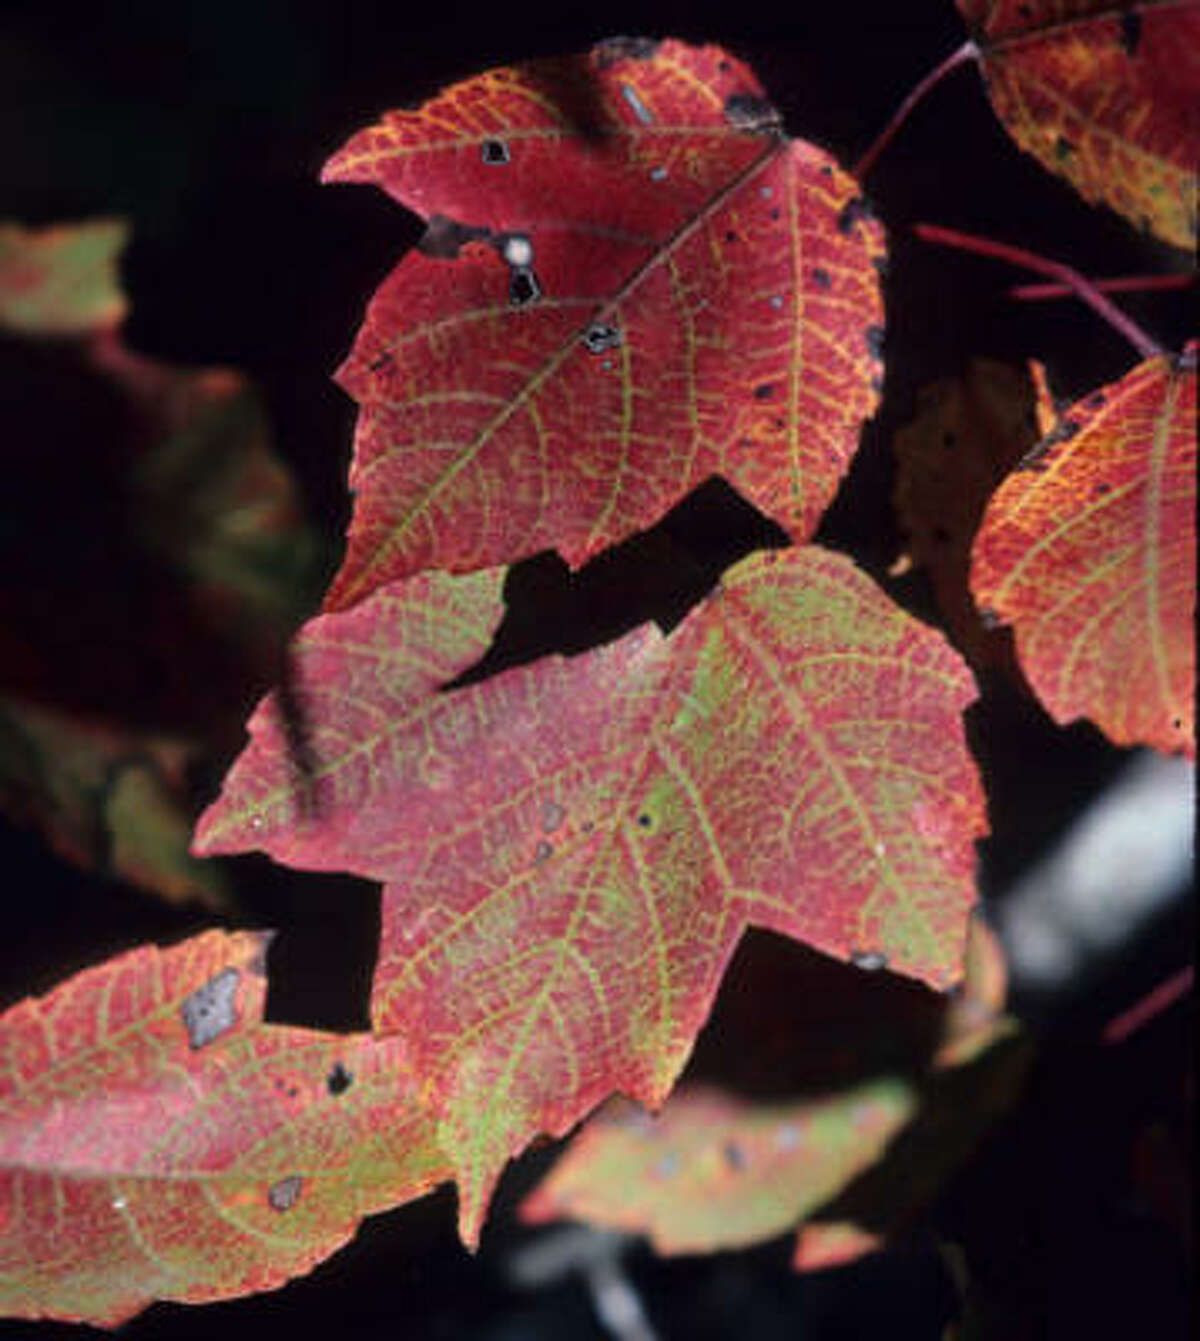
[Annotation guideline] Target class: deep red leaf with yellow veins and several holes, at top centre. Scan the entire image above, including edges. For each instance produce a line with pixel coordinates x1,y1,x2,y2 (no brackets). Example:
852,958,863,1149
324,42,884,609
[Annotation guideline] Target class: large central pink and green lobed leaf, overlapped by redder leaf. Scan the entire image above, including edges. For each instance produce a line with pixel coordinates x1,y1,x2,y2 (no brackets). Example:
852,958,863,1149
197,548,985,1240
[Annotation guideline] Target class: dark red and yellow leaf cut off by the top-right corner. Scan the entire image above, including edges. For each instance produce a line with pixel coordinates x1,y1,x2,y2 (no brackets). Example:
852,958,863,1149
957,0,1200,251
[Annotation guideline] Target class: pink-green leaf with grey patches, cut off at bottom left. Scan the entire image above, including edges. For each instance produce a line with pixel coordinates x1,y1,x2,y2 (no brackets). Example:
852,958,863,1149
0,932,448,1326
